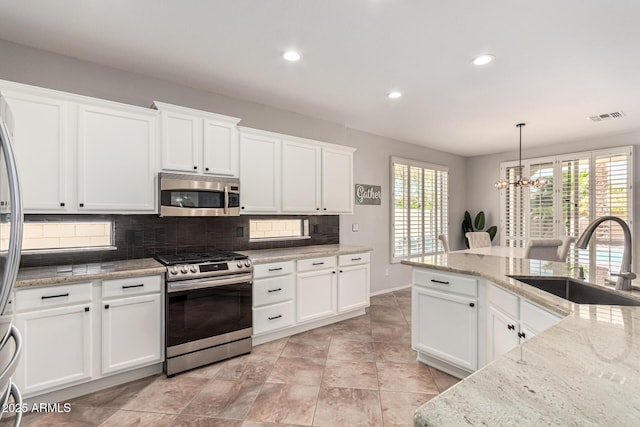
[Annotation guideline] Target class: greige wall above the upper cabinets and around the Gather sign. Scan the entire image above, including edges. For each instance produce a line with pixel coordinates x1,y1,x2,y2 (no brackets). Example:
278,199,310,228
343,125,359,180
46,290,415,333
0,40,467,292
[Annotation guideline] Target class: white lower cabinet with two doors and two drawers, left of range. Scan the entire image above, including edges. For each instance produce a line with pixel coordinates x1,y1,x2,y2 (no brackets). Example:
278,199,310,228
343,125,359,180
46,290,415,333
15,275,164,397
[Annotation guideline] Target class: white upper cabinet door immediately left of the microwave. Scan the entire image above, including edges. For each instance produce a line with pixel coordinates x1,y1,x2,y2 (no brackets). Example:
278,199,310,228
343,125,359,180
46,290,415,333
78,105,156,212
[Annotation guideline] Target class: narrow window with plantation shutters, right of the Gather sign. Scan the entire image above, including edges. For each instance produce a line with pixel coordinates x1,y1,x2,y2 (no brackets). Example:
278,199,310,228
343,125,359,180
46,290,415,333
391,157,449,262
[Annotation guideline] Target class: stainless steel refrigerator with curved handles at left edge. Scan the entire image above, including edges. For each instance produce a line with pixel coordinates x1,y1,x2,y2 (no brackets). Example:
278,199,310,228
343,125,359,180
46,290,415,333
0,94,23,426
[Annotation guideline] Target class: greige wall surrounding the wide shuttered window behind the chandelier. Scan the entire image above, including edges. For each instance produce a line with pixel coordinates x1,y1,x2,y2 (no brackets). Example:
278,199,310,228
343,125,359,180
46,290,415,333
466,129,640,272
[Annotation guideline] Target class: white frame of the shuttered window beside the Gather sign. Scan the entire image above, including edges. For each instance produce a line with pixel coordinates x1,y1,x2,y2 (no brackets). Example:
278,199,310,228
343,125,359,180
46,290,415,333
389,156,449,264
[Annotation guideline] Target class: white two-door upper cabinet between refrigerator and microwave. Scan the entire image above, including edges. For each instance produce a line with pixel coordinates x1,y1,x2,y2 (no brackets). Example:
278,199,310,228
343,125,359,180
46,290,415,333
0,81,158,213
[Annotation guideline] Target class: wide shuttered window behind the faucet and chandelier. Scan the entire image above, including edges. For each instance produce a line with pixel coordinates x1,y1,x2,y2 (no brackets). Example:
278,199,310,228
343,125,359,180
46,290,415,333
501,147,633,281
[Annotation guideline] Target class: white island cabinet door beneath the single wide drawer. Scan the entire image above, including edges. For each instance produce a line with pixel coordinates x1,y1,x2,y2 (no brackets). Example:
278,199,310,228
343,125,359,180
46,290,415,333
411,286,478,371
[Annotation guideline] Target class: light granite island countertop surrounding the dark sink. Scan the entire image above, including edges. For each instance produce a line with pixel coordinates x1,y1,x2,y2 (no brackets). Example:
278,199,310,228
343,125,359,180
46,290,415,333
403,253,640,426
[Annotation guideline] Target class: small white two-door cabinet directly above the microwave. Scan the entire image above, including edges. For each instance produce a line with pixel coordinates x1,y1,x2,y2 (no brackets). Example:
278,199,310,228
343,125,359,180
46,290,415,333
153,101,240,177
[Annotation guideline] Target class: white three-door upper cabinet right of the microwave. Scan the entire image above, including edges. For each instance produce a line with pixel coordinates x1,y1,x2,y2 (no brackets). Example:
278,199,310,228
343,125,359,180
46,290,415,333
240,128,355,214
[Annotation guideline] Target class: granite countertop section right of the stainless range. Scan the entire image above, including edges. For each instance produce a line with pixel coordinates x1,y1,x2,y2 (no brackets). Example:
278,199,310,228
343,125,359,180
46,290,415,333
238,244,373,264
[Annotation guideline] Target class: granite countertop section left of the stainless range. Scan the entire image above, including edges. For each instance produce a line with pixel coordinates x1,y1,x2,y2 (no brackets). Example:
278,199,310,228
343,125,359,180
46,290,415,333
15,258,167,288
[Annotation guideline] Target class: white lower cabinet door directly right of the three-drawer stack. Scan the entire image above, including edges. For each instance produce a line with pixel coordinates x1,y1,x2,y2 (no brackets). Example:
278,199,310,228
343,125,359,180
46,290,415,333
296,270,337,323
